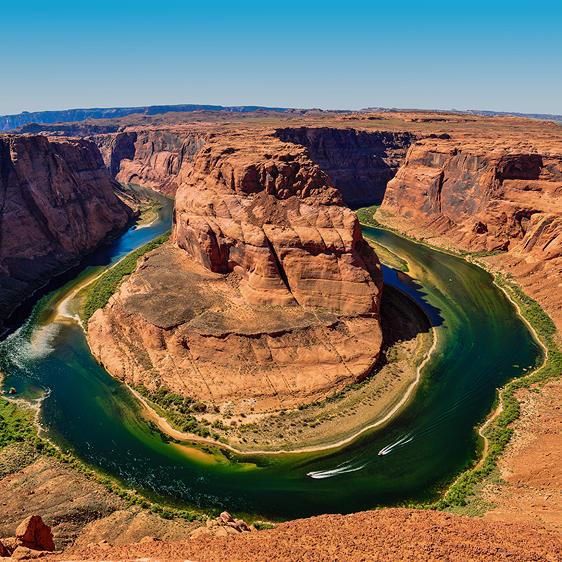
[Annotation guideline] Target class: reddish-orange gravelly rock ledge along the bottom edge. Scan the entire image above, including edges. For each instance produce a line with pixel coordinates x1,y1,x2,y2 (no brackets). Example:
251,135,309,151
41,509,562,562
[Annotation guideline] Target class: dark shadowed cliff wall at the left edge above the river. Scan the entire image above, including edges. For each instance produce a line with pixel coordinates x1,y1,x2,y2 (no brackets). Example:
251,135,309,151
0,135,133,320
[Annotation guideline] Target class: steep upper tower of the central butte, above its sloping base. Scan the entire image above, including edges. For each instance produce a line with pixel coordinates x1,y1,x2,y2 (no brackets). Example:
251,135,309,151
172,133,382,314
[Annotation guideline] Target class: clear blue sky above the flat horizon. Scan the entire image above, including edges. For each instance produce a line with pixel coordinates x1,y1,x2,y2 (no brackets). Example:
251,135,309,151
0,0,562,115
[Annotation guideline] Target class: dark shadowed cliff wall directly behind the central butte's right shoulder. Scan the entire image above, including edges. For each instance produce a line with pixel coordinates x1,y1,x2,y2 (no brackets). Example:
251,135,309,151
275,127,419,207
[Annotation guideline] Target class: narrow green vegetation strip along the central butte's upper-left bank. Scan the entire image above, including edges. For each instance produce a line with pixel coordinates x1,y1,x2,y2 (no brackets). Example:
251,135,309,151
80,231,170,329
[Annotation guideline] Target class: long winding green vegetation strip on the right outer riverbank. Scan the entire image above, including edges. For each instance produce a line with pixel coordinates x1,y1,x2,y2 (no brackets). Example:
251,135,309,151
429,274,562,510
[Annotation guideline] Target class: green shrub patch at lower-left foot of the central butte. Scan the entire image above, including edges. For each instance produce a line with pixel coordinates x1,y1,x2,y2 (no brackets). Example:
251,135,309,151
131,385,217,442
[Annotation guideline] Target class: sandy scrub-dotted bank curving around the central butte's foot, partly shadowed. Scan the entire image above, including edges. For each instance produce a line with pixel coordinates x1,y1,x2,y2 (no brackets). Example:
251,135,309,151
123,276,438,454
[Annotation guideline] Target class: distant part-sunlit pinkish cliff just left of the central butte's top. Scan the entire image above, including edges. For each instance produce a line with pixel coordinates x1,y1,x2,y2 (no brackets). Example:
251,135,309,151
91,127,208,197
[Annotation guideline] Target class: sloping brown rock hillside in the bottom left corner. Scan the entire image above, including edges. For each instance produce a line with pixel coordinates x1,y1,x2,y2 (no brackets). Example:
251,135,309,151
0,445,200,556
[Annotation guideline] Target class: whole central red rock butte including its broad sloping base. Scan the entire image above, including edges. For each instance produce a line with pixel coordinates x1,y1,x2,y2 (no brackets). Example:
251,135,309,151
88,134,382,411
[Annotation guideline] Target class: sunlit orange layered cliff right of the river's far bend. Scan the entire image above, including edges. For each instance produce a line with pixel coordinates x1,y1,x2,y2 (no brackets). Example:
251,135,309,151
381,135,562,328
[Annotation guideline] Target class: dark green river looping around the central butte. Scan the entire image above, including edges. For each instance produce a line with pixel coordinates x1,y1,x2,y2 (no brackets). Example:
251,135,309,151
0,212,541,518
